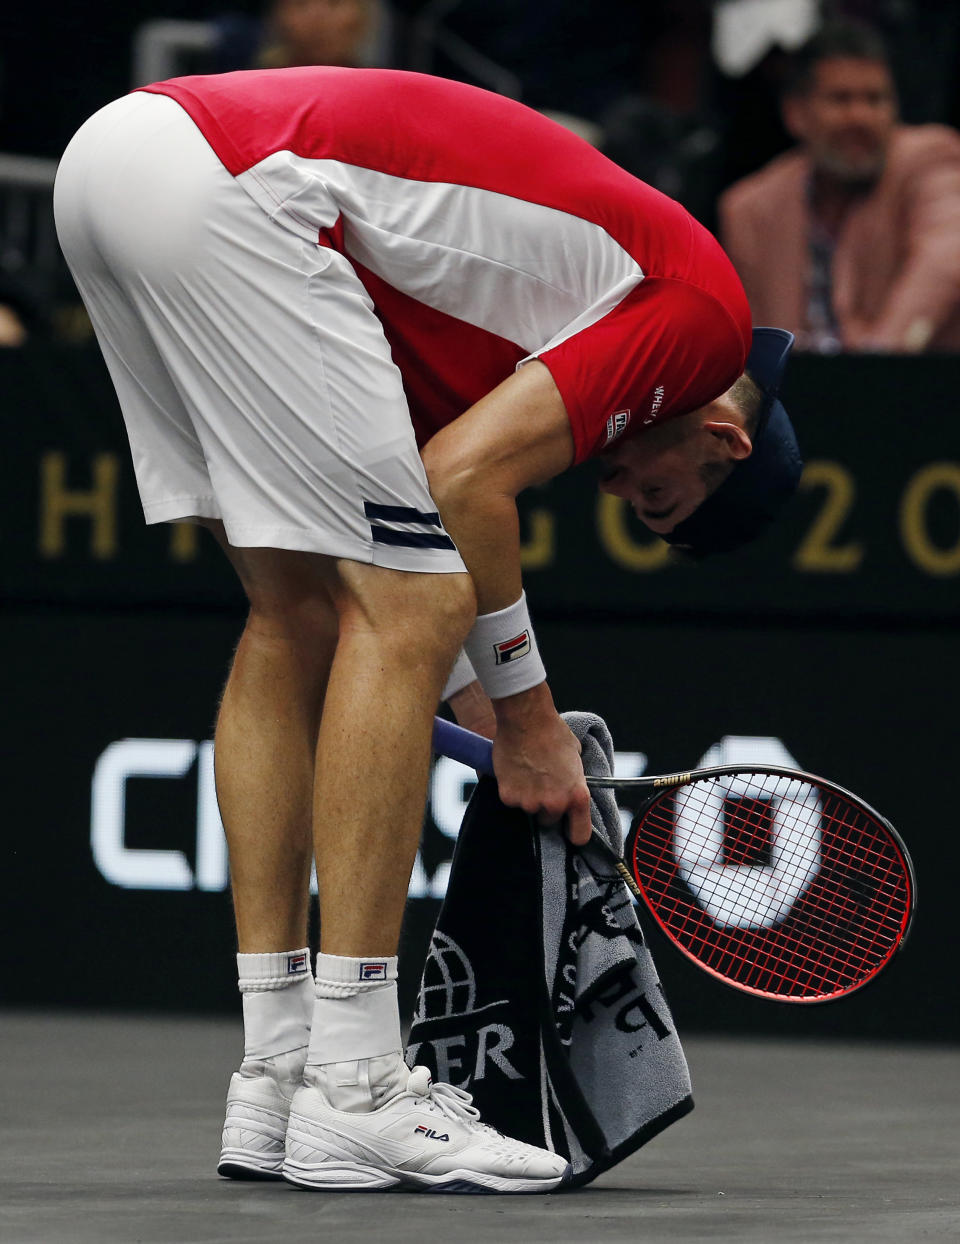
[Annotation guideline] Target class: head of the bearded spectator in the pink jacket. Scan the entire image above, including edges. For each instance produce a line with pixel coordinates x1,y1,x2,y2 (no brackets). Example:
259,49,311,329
783,21,897,184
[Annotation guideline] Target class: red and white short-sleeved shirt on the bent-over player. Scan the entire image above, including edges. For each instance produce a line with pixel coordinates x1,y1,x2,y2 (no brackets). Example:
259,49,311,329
145,67,751,462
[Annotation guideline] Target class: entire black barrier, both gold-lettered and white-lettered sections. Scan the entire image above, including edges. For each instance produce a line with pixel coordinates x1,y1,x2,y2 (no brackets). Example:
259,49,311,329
0,347,960,1039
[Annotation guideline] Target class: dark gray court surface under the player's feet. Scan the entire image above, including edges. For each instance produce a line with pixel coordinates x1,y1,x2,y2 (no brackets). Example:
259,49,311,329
0,1011,960,1244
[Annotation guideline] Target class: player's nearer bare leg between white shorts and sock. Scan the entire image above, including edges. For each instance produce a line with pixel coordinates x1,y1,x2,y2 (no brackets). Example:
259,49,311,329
315,562,474,957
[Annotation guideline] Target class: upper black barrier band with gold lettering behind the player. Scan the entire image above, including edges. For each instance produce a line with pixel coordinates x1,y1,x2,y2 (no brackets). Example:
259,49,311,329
0,347,960,618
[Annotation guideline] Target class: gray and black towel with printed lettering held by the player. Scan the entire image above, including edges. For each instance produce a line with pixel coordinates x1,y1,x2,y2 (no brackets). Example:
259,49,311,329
407,713,693,1184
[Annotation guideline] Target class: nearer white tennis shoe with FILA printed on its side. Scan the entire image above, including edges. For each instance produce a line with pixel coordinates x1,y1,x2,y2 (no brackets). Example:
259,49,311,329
284,1067,568,1192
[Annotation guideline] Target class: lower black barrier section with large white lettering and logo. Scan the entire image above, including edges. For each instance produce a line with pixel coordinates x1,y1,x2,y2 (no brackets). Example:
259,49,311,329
0,611,960,1039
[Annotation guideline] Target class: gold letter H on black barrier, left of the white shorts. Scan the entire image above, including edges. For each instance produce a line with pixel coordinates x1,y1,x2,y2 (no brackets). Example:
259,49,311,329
40,449,119,561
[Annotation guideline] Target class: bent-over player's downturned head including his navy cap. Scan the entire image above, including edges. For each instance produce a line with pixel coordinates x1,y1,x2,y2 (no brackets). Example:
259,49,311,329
601,328,802,557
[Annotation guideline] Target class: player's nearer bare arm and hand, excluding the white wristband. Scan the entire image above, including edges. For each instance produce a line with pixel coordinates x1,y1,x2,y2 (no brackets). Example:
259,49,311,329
423,362,591,842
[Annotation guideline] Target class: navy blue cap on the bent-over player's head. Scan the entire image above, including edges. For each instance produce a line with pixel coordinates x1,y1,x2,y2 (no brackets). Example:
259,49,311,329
663,328,803,557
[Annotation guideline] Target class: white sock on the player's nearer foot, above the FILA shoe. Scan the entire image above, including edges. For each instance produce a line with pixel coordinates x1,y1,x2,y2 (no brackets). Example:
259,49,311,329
307,954,408,1111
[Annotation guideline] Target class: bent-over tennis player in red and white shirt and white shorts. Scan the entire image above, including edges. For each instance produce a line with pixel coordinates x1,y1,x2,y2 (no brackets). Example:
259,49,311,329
55,68,798,1192
